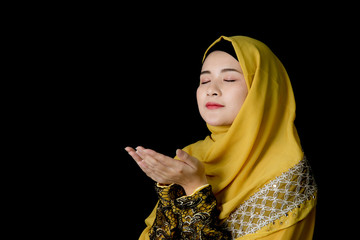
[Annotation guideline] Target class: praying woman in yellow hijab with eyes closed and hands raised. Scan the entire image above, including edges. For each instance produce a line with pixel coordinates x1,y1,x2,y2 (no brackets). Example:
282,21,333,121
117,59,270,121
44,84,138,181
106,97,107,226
126,36,317,239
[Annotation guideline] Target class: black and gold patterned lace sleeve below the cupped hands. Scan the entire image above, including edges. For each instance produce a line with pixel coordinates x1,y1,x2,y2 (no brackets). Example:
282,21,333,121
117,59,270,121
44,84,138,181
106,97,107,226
149,185,231,240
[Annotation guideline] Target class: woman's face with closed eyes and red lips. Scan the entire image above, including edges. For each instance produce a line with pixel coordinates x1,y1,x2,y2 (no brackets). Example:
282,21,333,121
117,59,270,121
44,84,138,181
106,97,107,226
196,51,248,126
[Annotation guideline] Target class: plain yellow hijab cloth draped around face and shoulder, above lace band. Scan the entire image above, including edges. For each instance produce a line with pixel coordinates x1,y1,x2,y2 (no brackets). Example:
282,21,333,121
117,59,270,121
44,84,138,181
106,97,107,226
139,36,314,240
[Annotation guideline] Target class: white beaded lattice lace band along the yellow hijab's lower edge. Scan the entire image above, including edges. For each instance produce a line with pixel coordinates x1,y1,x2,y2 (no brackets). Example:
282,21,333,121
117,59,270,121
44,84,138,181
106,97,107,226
225,157,317,239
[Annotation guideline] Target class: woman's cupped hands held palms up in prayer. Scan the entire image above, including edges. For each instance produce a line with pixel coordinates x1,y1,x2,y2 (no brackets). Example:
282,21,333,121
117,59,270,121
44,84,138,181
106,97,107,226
125,147,207,195
